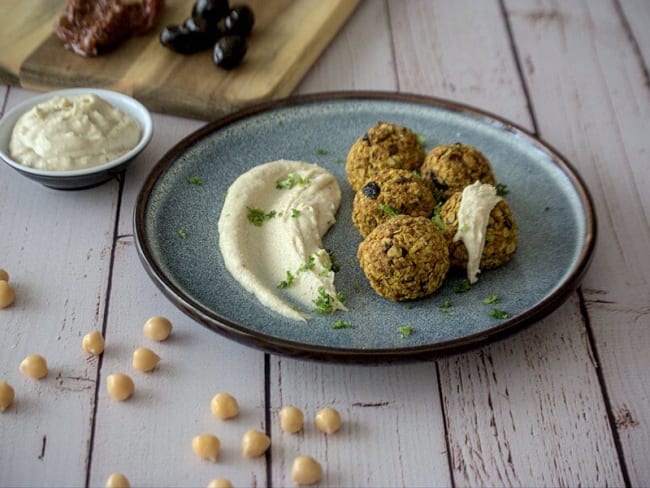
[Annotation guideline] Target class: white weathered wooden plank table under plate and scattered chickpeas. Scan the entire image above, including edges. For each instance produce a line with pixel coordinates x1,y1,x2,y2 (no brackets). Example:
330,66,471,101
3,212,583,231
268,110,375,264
0,0,650,487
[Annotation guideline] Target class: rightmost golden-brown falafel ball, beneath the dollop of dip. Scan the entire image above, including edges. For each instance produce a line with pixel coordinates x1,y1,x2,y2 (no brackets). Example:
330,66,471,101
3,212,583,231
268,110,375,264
440,192,519,269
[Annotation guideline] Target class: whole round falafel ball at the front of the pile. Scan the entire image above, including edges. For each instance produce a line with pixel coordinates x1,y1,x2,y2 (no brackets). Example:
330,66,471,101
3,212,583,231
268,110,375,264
357,215,449,301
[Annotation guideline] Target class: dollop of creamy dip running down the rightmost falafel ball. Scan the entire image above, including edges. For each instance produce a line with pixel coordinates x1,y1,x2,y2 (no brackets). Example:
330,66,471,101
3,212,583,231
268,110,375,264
454,181,501,283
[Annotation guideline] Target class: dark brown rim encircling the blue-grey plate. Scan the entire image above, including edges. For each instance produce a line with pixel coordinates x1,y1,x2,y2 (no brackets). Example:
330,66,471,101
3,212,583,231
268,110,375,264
133,91,597,363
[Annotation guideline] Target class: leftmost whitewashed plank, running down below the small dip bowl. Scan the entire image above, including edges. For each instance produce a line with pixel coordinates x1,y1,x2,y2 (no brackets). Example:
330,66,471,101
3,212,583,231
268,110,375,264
0,89,118,486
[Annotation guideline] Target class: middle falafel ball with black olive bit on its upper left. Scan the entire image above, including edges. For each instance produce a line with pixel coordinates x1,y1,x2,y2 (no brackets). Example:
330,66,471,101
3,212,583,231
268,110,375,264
352,169,436,237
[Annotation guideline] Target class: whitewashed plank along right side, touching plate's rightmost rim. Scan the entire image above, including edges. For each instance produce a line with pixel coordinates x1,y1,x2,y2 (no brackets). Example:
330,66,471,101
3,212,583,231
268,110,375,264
508,1,650,486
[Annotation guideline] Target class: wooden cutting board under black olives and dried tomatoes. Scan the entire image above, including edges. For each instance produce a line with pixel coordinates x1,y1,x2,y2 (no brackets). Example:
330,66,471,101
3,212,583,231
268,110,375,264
0,0,359,120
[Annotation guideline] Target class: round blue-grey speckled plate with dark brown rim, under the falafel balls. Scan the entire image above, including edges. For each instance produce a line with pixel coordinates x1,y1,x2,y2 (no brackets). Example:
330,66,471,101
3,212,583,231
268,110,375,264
134,92,596,362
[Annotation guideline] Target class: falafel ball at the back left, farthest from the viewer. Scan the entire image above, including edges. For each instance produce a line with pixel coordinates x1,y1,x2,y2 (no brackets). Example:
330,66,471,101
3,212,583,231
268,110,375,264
345,122,424,191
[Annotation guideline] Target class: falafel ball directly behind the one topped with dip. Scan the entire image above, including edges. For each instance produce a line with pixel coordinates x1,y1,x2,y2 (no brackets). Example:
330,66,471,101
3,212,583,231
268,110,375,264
420,142,496,201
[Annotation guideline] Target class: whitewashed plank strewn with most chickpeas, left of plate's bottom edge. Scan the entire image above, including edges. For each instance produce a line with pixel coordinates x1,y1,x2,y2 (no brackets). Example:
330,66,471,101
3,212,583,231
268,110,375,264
90,237,266,487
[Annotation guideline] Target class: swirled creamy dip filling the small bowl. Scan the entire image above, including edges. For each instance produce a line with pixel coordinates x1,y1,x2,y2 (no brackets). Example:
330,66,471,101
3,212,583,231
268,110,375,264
9,94,141,171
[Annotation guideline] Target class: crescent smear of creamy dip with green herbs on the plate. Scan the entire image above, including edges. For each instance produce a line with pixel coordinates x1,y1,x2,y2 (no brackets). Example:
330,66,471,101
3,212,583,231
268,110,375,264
219,160,345,320
